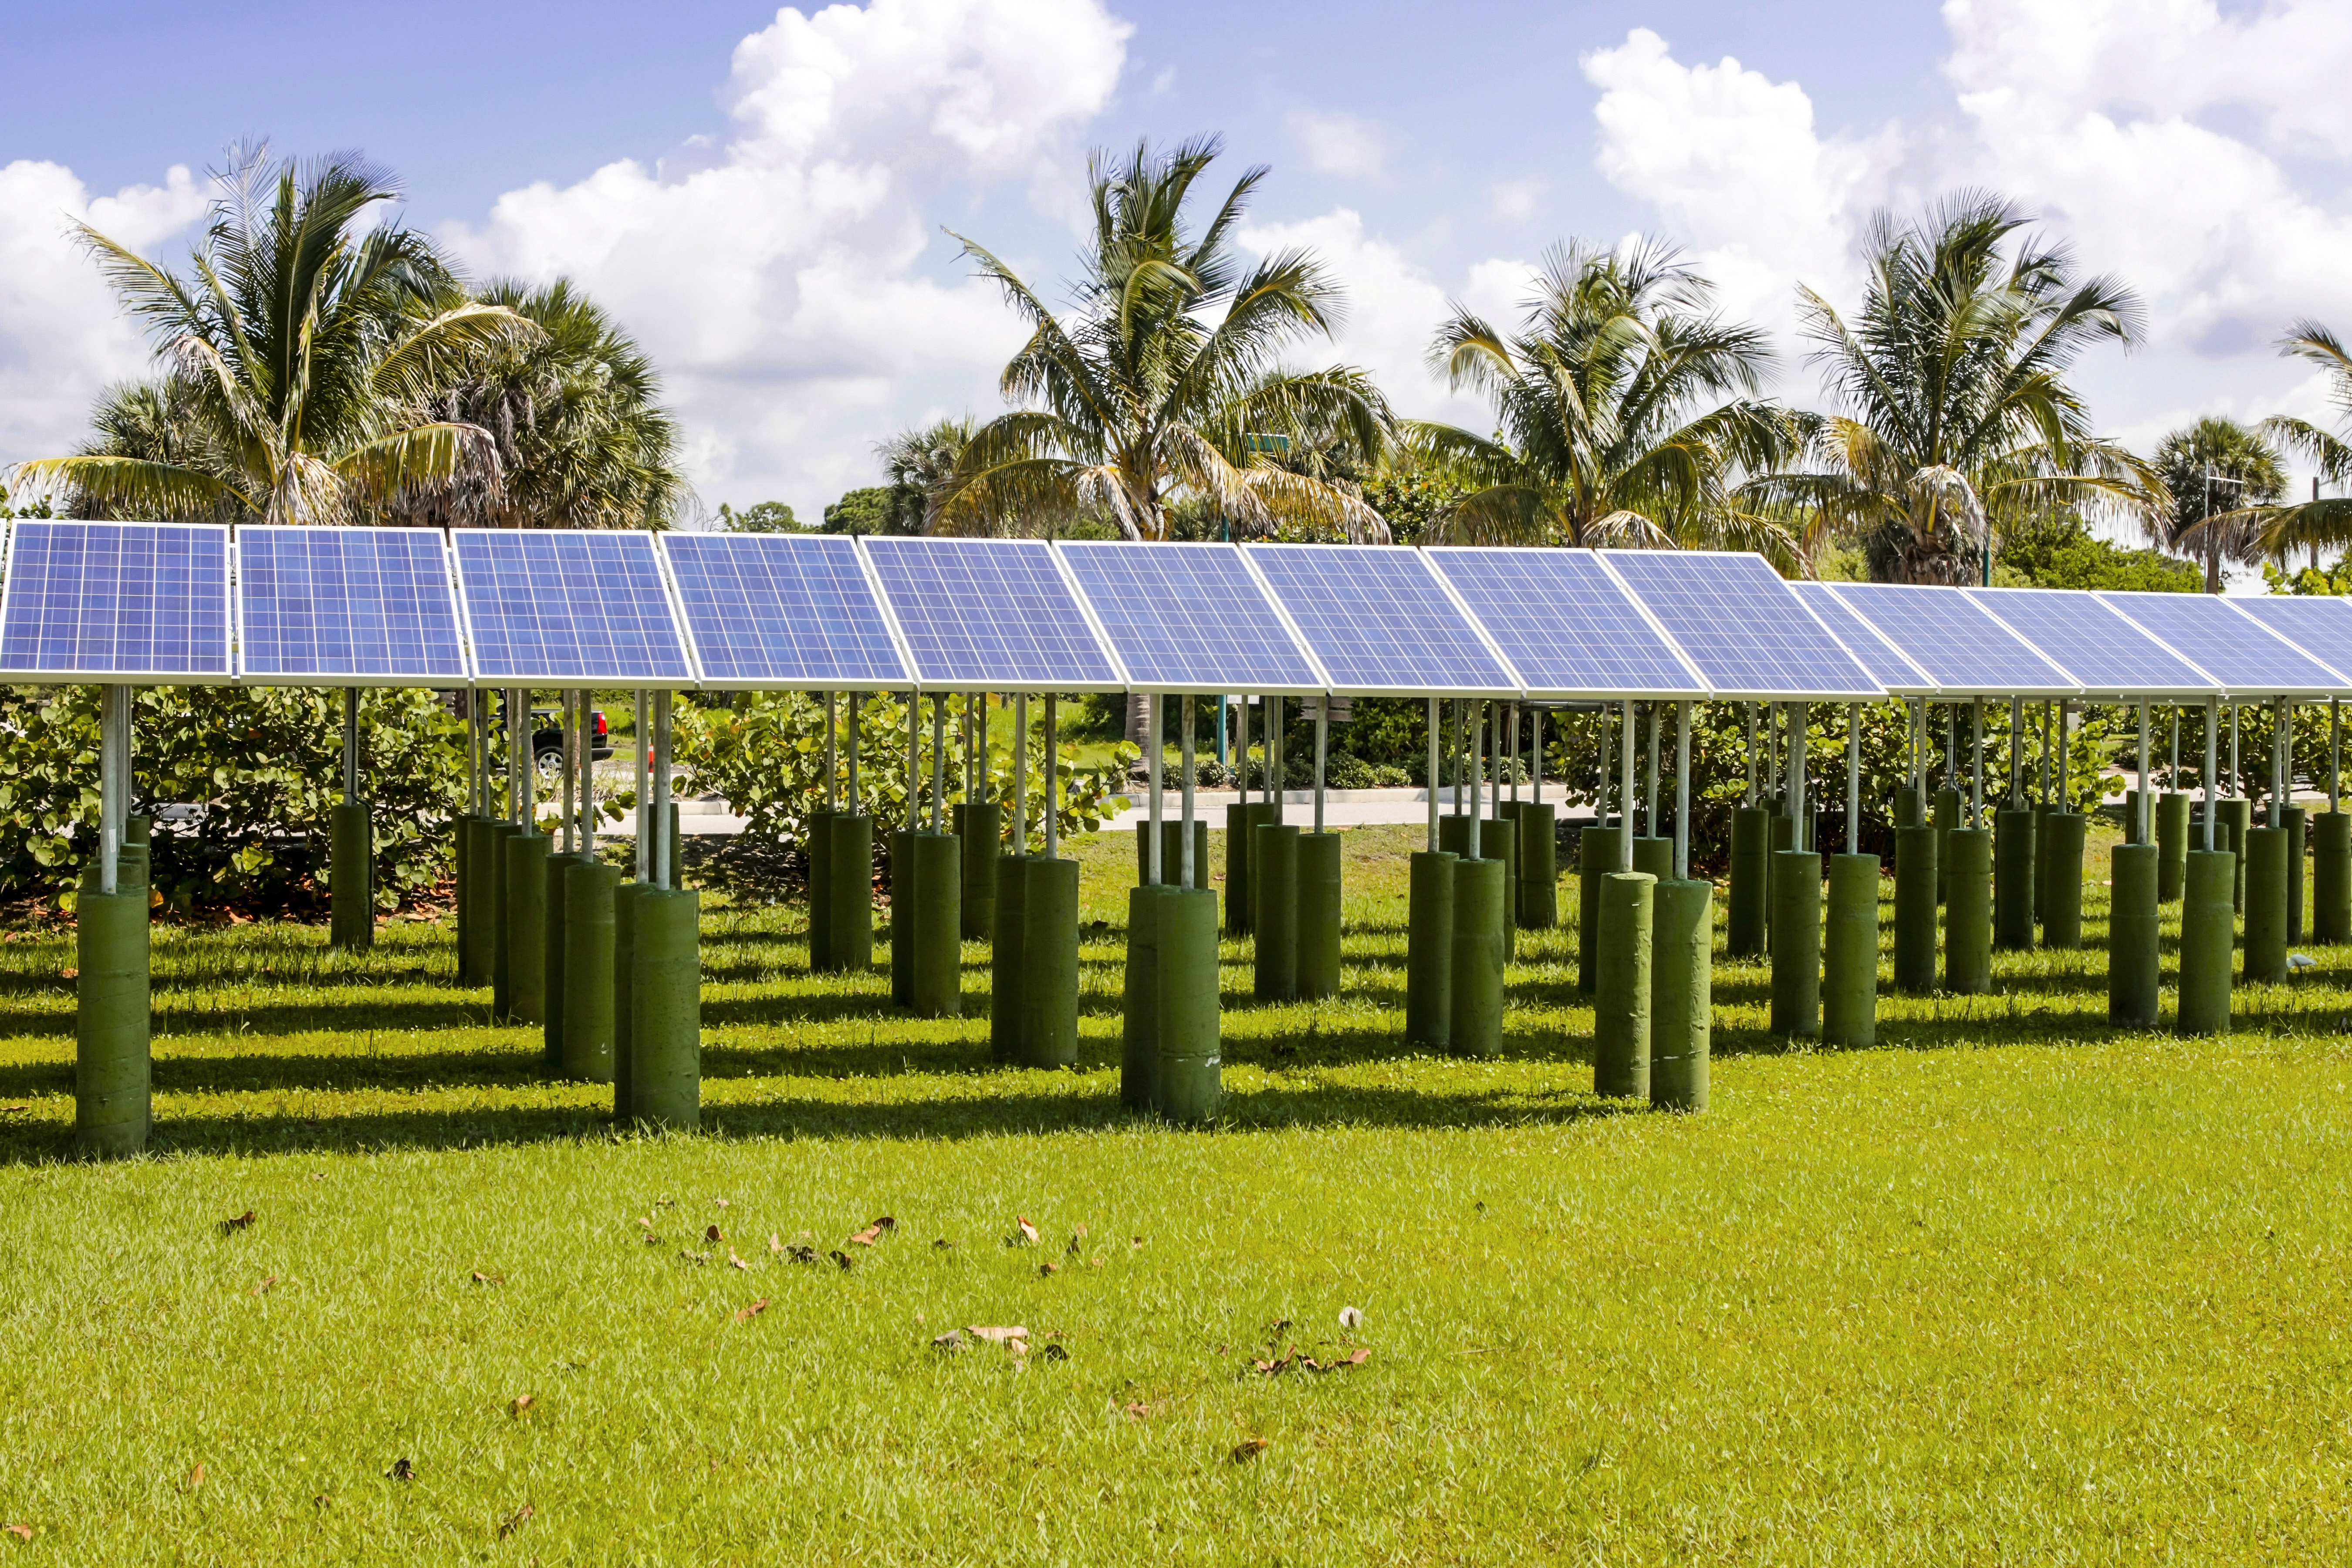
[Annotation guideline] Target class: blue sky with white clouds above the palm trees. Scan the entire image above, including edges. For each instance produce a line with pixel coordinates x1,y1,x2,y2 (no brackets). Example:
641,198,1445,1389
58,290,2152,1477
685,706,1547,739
0,0,2352,545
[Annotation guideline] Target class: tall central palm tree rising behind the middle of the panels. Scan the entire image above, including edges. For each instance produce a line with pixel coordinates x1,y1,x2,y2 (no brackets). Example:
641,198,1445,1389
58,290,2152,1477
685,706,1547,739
929,136,1395,538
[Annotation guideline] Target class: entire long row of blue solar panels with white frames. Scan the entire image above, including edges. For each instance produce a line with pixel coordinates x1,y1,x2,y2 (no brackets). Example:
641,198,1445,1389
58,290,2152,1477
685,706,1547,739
0,520,2352,700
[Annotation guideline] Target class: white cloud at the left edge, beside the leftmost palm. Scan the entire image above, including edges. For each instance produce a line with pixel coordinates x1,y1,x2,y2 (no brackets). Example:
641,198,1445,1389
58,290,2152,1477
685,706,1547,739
0,160,205,482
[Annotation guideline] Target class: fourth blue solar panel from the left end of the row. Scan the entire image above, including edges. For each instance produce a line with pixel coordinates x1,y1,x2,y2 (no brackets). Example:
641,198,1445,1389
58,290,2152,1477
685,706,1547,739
661,534,908,689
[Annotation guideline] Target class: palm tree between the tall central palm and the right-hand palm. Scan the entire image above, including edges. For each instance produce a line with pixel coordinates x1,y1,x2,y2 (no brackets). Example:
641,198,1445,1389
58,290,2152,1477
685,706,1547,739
1411,240,1797,564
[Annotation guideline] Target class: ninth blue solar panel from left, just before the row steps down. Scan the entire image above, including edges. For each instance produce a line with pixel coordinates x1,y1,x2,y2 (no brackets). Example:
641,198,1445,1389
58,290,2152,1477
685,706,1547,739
1602,550,1884,700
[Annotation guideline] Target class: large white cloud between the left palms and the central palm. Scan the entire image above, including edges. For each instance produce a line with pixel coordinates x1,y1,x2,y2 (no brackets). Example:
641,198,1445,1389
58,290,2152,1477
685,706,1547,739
449,0,1131,510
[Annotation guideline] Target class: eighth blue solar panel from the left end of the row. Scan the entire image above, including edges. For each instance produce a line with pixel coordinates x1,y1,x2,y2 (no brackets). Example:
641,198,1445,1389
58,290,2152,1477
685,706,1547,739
1428,550,1707,698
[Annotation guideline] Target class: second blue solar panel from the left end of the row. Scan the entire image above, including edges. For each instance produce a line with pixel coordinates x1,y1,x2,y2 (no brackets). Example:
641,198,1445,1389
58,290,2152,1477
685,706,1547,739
237,527,466,684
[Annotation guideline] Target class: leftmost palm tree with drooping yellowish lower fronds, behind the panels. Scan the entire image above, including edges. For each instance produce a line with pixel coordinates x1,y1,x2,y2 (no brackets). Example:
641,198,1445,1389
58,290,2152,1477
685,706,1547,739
12,146,539,522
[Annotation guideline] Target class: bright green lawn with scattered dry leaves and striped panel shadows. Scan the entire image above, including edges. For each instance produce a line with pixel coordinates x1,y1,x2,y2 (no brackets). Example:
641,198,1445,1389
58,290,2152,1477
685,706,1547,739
0,828,2352,1563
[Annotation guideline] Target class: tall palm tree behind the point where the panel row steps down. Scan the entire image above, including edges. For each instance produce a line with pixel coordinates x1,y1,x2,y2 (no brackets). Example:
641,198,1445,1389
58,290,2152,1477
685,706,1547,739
1762,193,2169,583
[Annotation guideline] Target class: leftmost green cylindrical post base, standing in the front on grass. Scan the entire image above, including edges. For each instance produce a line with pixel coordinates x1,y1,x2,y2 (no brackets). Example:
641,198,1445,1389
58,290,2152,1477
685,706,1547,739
73,889,155,1159
